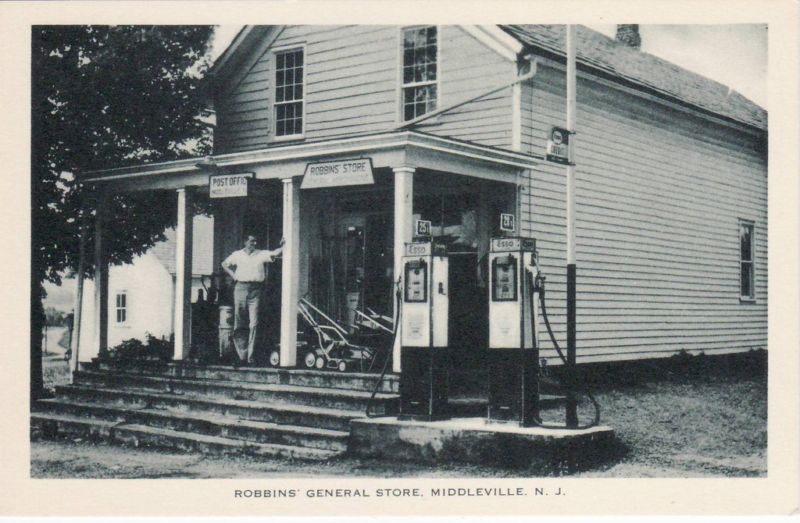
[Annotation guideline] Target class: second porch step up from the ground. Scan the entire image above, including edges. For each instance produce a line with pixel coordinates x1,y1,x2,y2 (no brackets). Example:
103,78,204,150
36,398,349,452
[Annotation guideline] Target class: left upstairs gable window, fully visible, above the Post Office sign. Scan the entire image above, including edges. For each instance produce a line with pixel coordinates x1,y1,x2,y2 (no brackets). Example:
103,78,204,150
274,49,303,136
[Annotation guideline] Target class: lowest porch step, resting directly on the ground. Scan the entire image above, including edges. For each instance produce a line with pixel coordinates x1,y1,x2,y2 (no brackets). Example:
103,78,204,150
31,413,341,460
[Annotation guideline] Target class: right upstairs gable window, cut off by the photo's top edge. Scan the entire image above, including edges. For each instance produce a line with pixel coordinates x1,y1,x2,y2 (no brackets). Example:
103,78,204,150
402,27,439,121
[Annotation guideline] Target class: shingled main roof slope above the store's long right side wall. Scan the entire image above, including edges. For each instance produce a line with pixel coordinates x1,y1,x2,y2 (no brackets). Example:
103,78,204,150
500,25,767,131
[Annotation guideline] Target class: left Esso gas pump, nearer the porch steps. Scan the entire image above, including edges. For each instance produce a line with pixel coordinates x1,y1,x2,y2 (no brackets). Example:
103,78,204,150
400,241,449,421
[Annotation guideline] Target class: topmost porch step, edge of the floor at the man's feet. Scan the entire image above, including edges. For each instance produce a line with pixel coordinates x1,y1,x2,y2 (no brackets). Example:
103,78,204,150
91,362,400,393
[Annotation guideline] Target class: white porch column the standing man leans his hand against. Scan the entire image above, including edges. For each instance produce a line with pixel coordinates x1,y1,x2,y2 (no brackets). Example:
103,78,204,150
280,178,300,367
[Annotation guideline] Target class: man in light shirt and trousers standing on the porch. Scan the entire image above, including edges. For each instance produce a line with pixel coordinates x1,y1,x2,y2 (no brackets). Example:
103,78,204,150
222,235,284,367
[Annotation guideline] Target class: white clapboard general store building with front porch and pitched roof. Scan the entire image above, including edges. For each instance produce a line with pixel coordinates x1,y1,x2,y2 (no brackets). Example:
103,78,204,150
80,25,767,372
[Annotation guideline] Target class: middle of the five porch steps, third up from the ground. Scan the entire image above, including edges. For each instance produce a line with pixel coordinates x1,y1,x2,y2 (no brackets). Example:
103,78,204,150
56,385,364,431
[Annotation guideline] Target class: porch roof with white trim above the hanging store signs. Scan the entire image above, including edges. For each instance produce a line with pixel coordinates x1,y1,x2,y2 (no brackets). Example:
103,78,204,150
78,130,542,192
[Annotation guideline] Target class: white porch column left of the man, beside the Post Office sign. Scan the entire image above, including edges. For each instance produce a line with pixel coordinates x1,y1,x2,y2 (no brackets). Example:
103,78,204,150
172,187,193,361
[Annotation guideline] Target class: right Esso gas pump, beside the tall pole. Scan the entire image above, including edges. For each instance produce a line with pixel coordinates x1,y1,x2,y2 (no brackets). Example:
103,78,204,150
488,237,539,427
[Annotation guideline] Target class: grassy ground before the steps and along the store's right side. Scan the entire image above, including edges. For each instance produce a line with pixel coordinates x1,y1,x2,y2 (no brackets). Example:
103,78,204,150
31,353,767,478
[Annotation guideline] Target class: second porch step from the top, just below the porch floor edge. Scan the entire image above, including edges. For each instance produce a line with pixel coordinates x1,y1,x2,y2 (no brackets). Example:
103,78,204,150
74,371,399,413
